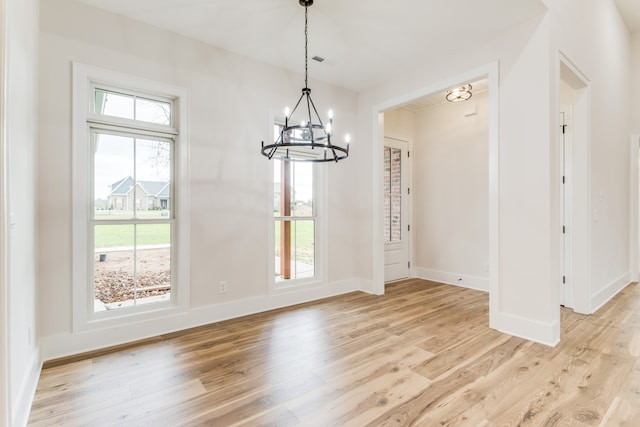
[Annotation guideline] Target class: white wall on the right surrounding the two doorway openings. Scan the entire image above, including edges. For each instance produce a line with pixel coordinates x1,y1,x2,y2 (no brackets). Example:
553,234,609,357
359,0,630,344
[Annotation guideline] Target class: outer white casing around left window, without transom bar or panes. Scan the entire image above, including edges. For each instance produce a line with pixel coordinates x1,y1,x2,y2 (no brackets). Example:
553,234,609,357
72,63,189,333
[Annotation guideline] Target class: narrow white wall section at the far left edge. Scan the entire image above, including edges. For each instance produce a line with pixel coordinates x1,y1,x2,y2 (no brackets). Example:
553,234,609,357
1,0,40,426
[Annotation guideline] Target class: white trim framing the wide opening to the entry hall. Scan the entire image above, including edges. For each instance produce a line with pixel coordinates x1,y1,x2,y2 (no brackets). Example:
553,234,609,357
372,61,500,334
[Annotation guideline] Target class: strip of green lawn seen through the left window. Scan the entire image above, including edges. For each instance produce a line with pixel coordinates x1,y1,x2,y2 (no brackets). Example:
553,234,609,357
94,224,171,248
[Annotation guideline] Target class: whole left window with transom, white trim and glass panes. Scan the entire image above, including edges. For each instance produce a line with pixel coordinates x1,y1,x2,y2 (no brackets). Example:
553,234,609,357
73,64,188,329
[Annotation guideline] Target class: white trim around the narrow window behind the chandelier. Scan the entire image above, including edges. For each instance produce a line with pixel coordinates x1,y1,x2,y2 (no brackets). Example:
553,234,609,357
266,114,328,294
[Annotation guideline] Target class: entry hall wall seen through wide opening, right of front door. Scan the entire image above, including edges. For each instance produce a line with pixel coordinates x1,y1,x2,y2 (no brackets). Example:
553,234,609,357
412,91,489,291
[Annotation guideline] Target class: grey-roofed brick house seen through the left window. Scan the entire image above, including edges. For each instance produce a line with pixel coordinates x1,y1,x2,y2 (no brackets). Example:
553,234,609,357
108,176,171,210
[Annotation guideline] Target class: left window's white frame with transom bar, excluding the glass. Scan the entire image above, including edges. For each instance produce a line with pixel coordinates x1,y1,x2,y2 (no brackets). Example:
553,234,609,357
72,63,189,332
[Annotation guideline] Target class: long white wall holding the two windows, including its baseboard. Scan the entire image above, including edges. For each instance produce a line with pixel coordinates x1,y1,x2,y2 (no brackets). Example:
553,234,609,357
38,0,367,359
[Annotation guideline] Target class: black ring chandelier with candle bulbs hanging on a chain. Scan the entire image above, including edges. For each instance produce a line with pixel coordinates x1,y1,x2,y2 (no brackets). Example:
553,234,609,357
261,0,350,162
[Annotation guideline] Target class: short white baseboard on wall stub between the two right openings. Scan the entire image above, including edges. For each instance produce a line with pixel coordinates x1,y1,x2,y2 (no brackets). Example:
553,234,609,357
489,313,560,347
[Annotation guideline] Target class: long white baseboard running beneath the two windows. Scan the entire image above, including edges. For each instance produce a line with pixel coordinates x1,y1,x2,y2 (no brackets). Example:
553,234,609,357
40,278,372,361
